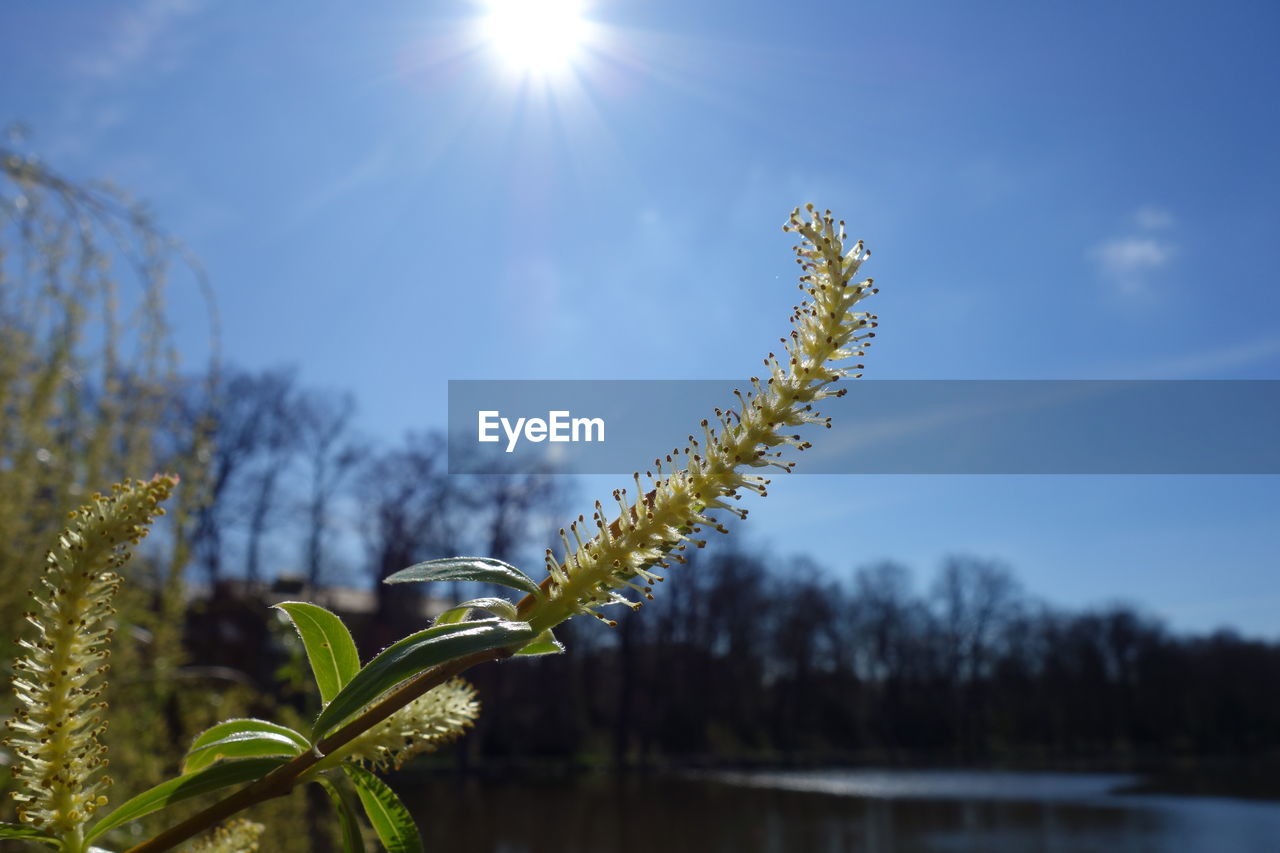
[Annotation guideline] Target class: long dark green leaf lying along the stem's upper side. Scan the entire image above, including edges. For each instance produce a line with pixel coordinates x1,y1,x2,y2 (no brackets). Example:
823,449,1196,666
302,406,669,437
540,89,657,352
314,619,534,740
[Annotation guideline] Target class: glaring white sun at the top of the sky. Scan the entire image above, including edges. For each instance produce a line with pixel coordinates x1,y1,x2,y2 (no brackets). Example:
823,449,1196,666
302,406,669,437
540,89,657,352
484,0,586,74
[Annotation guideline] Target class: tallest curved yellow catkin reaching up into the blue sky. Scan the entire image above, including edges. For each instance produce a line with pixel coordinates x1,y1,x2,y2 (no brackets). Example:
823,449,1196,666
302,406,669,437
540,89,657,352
521,205,877,631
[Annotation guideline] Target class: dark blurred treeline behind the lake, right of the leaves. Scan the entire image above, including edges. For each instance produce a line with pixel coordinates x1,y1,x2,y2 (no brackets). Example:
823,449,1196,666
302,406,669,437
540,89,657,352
471,551,1280,763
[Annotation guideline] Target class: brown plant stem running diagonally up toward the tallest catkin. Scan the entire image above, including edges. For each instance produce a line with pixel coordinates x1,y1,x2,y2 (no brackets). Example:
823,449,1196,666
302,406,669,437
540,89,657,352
125,648,513,853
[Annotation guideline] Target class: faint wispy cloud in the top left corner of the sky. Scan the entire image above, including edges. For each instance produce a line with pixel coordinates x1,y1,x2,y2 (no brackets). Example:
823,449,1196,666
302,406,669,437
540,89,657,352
73,0,202,81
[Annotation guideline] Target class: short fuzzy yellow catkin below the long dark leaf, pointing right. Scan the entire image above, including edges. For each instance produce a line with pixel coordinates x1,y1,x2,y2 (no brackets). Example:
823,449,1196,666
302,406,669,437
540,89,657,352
344,679,480,770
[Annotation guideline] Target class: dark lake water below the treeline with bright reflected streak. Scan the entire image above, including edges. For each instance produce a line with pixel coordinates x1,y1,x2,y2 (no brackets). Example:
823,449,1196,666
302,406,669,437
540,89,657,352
402,770,1280,853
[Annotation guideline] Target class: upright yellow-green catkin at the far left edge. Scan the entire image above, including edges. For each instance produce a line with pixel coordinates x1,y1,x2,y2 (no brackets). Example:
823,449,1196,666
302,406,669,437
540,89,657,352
5,475,178,849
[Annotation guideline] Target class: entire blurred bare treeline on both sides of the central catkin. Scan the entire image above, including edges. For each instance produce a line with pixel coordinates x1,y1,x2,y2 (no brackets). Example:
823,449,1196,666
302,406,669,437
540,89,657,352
154,371,1280,763
